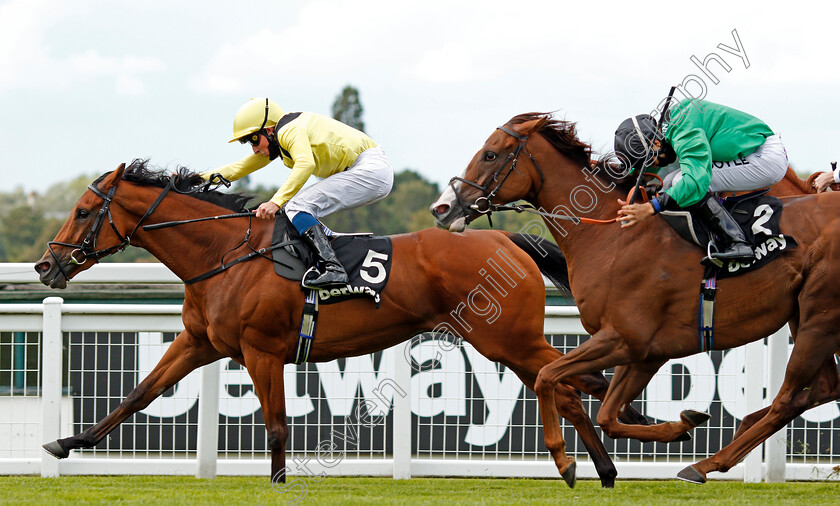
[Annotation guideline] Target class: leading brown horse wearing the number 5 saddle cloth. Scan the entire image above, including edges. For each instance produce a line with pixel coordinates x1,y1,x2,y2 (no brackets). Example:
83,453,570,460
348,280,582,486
35,161,646,486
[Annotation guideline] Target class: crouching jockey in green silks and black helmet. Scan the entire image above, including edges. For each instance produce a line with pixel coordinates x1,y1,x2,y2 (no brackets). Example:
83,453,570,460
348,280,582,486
615,99,788,260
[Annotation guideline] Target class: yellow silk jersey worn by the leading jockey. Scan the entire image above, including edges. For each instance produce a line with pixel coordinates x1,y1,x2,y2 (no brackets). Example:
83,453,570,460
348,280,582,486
201,112,378,206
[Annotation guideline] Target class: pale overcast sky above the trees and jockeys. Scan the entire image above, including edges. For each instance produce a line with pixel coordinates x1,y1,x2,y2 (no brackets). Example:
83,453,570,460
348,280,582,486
0,0,840,196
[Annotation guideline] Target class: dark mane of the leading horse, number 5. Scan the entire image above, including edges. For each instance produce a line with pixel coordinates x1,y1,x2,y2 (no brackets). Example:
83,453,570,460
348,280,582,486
93,158,253,213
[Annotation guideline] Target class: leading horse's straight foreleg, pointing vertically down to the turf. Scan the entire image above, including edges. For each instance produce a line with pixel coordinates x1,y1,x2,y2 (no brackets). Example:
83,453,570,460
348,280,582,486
243,348,289,483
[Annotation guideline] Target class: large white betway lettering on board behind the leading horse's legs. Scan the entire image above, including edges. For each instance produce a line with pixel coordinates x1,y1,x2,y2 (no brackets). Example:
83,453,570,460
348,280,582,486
138,332,524,446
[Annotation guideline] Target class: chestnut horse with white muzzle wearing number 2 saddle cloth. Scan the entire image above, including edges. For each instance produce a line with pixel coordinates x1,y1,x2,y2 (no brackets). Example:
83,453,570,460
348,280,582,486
432,113,840,483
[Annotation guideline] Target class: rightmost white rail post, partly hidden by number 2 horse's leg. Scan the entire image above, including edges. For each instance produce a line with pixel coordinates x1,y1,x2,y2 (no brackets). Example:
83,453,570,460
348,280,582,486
764,325,790,483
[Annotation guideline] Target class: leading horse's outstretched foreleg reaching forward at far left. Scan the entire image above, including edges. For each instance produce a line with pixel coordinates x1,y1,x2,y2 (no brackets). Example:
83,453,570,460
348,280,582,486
44,331,222,459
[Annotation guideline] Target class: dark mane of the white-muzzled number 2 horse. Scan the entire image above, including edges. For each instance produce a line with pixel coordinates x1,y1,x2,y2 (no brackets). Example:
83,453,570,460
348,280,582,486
508,112,636,191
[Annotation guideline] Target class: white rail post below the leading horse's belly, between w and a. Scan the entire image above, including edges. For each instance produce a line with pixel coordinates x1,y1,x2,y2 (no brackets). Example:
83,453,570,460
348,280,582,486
393,339,412,480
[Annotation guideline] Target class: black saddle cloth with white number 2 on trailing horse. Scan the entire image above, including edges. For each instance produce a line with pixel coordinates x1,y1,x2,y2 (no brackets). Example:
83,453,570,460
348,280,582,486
662,191,797,278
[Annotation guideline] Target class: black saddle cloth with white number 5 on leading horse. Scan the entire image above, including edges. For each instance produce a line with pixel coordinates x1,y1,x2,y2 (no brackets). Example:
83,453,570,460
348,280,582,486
271,211,393,304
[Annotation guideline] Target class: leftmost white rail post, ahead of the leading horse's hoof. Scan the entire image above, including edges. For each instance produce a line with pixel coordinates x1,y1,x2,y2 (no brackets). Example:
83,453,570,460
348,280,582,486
41,297,64,478
